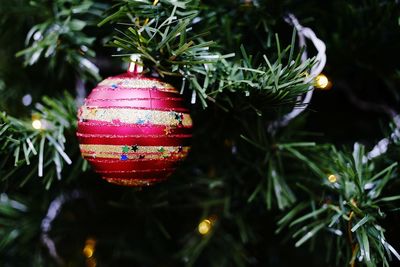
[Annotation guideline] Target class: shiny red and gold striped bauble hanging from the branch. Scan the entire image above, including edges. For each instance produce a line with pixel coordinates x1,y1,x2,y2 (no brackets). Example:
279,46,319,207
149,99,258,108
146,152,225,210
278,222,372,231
77,72,192,186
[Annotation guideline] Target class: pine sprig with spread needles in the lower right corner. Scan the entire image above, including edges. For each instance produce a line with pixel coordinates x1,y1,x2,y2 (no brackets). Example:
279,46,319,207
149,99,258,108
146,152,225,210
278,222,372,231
278,144,400,266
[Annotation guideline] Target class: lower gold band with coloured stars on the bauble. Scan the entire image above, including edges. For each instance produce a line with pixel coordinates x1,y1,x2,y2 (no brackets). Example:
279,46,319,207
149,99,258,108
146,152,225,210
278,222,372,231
79,144,190,154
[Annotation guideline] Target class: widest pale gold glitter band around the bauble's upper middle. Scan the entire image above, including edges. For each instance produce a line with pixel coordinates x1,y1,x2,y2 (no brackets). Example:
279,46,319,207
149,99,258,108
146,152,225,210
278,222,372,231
80,106,192,127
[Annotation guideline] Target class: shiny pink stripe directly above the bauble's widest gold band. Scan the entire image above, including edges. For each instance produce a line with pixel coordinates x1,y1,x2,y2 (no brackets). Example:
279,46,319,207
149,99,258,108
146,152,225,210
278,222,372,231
85,98,189,113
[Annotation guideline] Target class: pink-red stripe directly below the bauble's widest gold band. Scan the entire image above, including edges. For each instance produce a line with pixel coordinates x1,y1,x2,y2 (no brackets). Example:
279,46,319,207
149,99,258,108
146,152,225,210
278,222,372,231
78,122,192,136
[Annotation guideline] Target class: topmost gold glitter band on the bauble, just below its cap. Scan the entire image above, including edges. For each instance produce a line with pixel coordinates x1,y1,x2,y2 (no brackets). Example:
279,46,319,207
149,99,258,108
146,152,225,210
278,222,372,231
99,78,178,94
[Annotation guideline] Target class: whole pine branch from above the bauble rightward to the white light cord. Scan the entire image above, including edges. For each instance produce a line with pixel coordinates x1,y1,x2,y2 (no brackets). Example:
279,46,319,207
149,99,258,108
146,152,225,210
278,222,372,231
100,1,313,108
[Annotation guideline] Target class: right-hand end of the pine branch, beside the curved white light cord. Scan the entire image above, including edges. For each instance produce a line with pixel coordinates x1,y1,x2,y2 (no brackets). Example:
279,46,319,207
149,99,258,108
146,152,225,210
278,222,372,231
208,40,314,112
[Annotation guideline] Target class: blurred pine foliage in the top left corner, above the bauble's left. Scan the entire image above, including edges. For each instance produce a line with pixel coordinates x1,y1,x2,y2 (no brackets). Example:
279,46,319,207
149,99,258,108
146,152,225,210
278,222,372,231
16,0,106,80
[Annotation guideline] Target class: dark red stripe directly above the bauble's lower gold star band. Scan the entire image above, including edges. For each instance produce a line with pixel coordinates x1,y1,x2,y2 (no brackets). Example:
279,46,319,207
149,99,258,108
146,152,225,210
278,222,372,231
77,133,192,146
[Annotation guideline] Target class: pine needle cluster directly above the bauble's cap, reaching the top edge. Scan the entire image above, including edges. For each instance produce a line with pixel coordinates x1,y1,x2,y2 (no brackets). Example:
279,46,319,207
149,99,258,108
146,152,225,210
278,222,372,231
100,0,223,77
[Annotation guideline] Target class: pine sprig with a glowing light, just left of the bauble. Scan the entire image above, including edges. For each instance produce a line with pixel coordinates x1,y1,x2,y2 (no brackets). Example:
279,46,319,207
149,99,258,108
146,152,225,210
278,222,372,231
0,93,76,189
